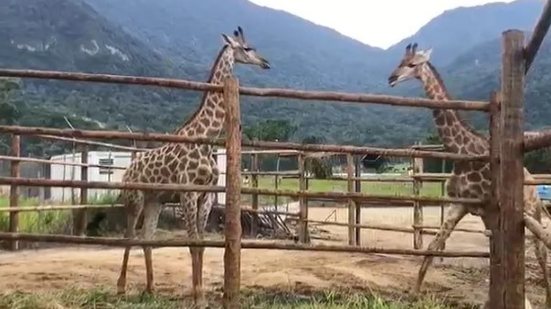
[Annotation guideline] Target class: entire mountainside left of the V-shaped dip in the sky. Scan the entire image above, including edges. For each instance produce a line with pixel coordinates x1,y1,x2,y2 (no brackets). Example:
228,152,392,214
4,0,424,150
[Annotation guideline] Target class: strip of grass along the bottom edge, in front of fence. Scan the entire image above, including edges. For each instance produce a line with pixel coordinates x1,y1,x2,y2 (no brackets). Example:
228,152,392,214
0,287,460,309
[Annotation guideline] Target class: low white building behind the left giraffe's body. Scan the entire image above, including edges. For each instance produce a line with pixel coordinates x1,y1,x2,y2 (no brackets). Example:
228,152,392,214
50,149,226,204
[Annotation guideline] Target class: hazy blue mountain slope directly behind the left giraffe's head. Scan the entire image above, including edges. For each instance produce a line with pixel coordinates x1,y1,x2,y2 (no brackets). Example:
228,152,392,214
86,0,424,144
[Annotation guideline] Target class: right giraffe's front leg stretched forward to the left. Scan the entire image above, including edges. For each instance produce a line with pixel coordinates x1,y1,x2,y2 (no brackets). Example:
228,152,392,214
413,204,468,294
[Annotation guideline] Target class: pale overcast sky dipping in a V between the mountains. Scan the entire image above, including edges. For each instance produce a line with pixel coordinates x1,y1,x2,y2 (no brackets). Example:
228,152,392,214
250,0,512,48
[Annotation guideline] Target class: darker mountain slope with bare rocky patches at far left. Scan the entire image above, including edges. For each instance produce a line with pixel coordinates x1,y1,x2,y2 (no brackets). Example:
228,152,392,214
0,0,196,138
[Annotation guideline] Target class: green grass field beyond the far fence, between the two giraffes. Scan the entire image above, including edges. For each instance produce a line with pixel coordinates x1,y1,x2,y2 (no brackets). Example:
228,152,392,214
243,176,442,205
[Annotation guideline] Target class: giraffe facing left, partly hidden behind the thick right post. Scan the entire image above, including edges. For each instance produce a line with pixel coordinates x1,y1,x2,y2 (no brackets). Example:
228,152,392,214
388,44,551,304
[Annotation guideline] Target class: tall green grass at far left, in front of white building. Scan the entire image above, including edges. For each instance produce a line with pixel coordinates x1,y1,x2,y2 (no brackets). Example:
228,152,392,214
0,197,71,233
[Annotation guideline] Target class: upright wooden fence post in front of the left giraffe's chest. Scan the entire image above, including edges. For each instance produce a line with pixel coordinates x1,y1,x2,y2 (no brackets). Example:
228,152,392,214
223,77,242,309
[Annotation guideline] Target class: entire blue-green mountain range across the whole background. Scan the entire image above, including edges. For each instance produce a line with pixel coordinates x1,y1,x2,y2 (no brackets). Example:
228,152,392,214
0,0,551,155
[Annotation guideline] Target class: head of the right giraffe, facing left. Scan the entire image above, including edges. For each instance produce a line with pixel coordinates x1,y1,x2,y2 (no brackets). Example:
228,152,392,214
388,43,432,87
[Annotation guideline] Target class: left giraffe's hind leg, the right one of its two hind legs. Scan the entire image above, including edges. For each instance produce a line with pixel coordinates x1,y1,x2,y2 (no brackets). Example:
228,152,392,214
141,197,162,293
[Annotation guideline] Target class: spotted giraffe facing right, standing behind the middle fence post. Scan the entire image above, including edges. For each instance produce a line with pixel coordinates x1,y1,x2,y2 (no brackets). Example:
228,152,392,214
117,27,270,306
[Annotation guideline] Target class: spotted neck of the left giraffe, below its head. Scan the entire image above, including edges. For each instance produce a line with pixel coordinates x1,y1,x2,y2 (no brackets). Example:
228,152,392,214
175,45,234,138
